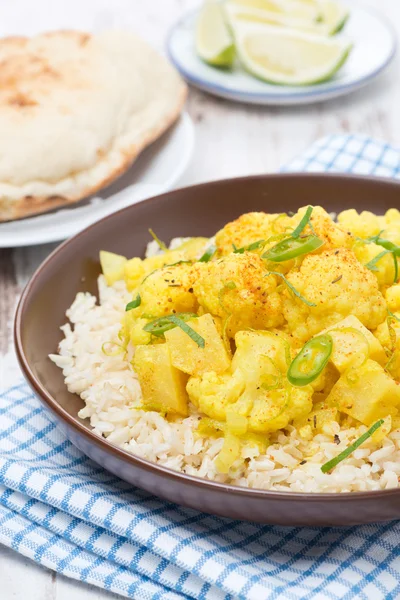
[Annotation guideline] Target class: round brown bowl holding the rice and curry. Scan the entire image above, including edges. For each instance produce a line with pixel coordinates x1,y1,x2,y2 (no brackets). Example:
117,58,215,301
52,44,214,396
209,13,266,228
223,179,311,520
15,174,400,526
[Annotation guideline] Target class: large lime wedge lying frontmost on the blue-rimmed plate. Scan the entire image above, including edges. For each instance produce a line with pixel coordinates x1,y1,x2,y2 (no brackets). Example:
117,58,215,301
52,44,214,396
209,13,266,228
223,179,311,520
231,21,351,85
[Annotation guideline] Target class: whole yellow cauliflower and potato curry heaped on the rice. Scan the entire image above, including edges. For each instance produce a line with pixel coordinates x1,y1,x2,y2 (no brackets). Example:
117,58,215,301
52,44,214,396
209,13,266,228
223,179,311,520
100,206,400,472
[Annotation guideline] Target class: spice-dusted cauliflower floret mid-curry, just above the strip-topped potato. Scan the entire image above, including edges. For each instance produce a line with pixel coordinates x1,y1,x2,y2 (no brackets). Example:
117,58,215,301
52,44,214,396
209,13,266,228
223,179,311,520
192,252,283,337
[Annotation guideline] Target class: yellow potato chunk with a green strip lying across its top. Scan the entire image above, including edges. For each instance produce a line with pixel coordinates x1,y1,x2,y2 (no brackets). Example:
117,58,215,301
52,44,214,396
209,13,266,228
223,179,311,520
165,314,231,375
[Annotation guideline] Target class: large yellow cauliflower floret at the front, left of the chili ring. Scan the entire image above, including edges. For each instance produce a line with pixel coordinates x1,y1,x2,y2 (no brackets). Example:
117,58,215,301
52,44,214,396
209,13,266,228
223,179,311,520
187,331,313,433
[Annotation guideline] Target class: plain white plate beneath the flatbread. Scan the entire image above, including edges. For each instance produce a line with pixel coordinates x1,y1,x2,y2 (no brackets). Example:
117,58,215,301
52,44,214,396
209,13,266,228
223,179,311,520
0,113,194,248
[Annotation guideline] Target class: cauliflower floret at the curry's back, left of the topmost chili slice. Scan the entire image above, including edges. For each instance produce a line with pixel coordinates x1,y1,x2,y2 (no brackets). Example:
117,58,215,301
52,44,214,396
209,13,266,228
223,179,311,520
215,212,290,255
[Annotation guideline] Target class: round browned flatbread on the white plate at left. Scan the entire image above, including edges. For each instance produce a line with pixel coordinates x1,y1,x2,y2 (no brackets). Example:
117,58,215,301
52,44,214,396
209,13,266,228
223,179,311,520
0,31,186,221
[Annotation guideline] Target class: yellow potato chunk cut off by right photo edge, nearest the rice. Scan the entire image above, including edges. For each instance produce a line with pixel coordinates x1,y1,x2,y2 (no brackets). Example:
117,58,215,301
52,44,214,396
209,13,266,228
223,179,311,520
326,360,400,425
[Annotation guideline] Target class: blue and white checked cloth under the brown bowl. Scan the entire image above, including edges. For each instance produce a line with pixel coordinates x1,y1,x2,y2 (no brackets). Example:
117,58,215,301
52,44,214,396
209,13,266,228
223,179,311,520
0,135,400,600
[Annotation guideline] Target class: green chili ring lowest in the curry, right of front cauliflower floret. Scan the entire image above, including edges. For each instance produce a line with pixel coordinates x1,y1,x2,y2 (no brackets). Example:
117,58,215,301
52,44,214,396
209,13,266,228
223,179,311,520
287,334,333,387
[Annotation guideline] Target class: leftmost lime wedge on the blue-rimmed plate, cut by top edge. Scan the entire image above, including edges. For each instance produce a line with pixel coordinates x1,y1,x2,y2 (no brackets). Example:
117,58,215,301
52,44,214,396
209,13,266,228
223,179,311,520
196,2,235,67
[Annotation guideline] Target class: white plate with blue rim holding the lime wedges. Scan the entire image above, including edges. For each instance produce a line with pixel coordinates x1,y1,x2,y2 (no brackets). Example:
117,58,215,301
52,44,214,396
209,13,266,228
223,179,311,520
167,0,399,105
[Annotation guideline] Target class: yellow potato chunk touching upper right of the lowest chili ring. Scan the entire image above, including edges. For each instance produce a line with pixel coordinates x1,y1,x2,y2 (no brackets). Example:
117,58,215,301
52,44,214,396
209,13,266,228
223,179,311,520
321,315,387,373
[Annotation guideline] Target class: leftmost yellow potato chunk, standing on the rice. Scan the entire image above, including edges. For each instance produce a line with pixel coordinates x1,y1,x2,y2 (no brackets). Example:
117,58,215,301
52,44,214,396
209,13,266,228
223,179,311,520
133,344,188,416
